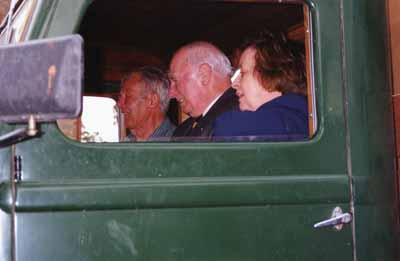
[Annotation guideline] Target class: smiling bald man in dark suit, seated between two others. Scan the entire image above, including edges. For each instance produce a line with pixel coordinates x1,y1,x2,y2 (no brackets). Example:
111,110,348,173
169,42,238,141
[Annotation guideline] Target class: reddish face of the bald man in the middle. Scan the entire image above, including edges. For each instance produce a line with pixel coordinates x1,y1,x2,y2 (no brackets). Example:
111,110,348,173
169,50,203,117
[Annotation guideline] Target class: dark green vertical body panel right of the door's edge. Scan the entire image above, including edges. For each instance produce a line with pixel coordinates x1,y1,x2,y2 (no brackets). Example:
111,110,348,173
343,0,397,260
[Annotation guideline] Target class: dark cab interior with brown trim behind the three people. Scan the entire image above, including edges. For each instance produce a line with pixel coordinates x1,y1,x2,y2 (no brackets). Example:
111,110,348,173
59,0,316,141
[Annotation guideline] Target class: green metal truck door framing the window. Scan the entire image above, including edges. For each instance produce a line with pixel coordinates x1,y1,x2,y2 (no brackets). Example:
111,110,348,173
0,0,353,261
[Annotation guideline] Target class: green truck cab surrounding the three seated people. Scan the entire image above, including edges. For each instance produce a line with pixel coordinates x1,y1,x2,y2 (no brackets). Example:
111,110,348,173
0,0,398,261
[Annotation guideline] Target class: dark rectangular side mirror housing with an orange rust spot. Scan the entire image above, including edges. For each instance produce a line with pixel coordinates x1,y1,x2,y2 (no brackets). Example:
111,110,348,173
0,35,83,147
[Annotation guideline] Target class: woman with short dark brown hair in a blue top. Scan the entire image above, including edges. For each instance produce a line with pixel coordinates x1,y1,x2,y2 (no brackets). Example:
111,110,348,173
214,32,308,140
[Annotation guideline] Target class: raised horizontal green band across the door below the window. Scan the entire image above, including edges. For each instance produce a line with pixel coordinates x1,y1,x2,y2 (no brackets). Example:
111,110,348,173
0,175,349,212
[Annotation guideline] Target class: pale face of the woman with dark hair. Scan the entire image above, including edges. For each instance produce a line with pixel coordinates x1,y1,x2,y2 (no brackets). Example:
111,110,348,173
233,47,267,111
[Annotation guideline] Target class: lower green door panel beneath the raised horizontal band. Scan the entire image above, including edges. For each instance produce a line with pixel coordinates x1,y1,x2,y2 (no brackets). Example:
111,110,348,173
17,204,351,261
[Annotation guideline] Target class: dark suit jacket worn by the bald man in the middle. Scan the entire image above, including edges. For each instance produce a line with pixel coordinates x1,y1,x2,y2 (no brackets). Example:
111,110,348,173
172,88,239,141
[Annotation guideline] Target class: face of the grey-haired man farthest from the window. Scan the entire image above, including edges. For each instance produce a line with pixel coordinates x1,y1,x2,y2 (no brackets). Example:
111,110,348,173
117,75,149,129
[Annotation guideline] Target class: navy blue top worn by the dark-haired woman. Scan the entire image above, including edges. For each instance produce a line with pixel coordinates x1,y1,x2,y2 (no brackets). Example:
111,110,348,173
214,93,308,141
